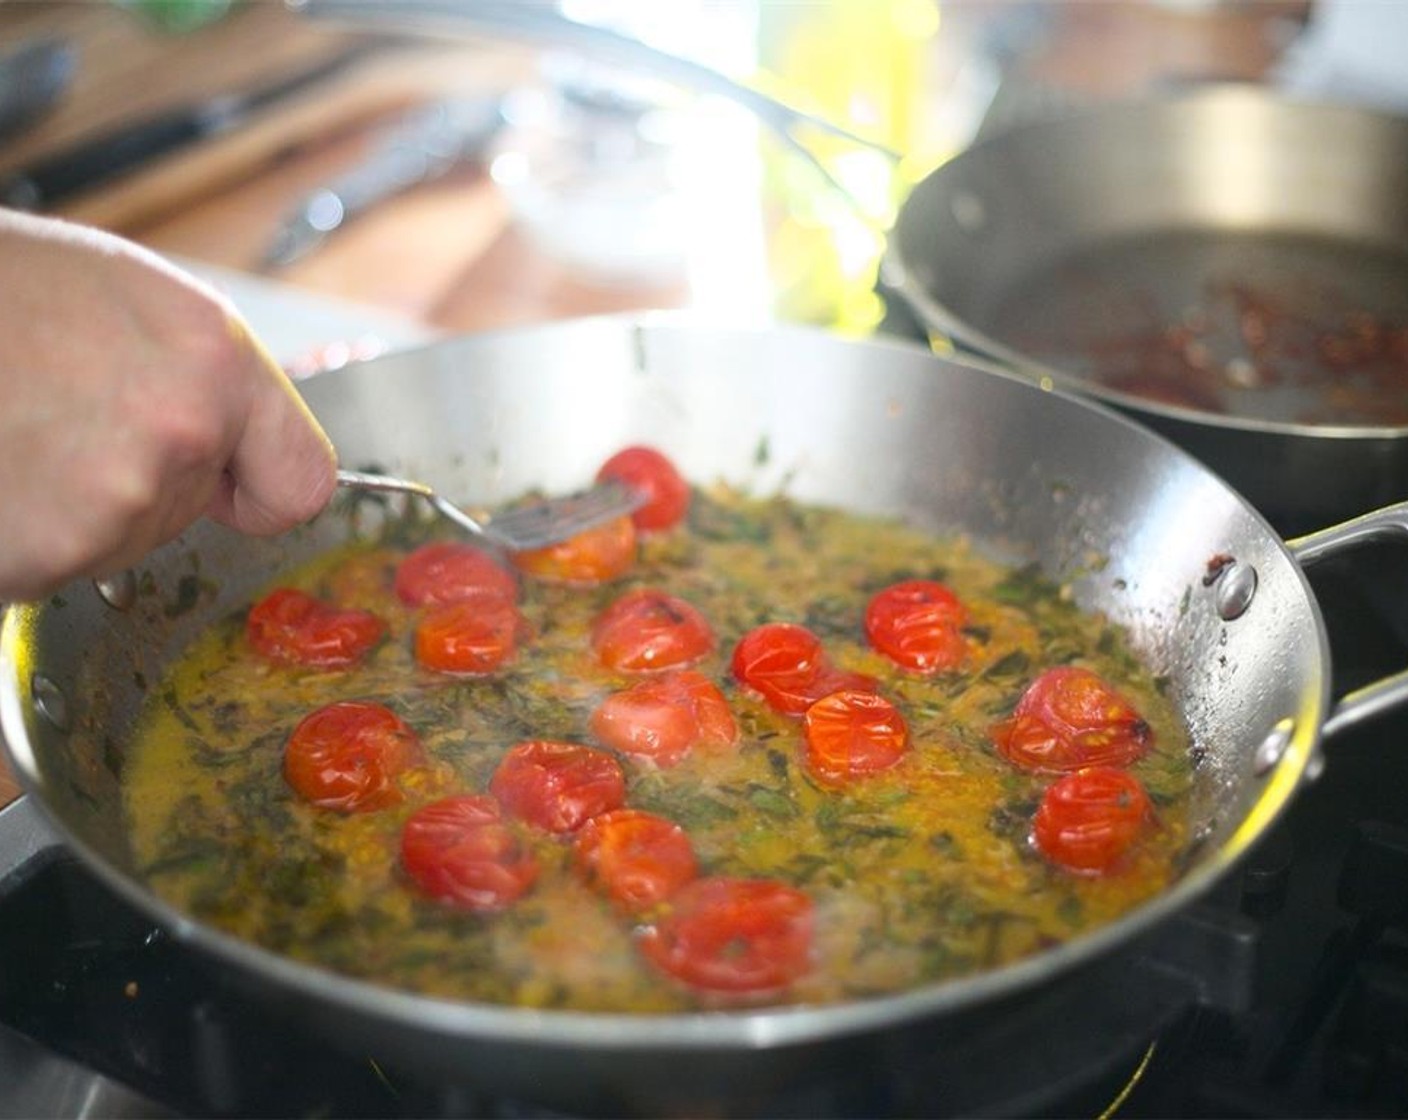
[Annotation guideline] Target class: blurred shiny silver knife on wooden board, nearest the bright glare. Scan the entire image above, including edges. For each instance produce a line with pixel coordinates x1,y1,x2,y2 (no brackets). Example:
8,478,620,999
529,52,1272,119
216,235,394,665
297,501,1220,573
262,97,505,270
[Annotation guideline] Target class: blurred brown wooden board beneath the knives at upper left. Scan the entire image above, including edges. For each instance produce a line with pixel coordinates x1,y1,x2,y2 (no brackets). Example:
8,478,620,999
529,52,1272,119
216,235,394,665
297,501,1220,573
0,0,704,331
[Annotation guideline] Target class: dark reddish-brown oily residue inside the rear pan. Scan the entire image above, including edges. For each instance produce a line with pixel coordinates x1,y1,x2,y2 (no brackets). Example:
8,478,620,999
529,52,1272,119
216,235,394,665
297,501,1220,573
974,231,1408,427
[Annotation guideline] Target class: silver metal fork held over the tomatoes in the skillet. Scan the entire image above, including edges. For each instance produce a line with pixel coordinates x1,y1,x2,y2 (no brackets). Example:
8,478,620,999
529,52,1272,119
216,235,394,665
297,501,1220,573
338,471,645,552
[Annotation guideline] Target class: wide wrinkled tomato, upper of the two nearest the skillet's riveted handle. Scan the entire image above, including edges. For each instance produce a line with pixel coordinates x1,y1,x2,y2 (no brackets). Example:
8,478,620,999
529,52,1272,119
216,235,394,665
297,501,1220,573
991,665,1153,773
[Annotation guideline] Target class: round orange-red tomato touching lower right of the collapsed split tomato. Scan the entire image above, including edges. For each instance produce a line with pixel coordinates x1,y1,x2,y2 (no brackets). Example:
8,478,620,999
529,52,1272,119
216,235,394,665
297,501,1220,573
803,692,910,786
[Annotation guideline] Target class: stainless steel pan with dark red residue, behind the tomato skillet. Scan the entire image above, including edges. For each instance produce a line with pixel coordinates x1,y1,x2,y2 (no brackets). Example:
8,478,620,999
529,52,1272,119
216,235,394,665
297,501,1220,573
884,86,1408,531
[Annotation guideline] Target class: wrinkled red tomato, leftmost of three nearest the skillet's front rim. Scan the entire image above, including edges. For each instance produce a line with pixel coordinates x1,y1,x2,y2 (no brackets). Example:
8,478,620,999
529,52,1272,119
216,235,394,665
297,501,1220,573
401,793,538,913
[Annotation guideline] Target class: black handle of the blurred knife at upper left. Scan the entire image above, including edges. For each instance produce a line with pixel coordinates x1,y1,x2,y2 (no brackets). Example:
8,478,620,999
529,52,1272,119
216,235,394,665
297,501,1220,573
0,99,239,210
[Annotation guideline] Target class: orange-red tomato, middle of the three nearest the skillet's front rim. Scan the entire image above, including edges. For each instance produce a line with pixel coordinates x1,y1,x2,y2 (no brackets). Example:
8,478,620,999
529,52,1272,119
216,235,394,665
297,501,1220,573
573,809,698,913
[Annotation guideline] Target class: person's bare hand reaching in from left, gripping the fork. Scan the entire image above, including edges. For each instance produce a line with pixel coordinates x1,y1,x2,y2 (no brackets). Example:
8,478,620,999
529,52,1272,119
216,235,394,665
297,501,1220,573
0,211,337,599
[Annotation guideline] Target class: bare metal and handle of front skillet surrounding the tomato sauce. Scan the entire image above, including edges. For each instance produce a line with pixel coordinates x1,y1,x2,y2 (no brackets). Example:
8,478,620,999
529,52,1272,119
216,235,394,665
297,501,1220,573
0,317,1408,1114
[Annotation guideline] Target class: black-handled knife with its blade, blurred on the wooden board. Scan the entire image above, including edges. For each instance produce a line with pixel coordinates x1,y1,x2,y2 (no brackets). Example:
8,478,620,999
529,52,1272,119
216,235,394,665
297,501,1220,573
0,42,376,210
